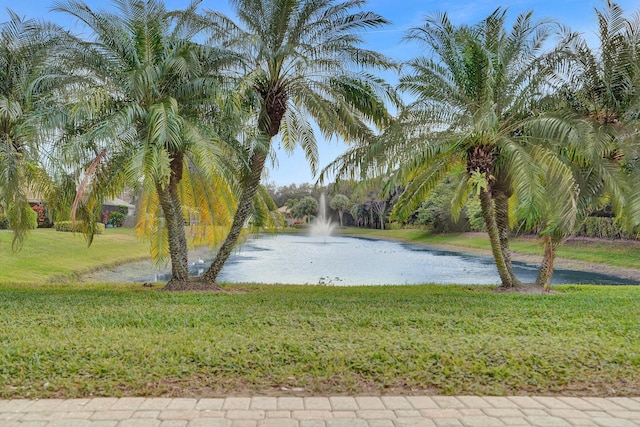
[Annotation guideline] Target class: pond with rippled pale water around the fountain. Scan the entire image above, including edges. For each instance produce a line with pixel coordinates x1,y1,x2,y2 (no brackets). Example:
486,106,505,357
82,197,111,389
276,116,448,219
85,234,637,286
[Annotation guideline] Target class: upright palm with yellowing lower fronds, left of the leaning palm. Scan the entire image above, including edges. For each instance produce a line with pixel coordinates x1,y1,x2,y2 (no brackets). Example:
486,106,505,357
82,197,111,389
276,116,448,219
55,0,239,289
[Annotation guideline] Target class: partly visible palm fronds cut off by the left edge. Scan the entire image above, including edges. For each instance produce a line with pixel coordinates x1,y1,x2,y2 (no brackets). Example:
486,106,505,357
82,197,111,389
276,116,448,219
0,10,59,249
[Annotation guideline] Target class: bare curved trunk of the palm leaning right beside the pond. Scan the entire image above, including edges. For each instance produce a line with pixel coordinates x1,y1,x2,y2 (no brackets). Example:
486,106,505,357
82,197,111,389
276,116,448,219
202,151,267,284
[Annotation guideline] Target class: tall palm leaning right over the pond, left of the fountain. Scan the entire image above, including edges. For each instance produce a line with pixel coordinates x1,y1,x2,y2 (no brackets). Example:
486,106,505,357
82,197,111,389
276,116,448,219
204,0,395,282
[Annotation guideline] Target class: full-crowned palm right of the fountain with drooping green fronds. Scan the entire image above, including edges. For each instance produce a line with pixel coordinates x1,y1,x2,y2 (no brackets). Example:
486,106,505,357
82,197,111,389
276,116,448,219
327,9,573,288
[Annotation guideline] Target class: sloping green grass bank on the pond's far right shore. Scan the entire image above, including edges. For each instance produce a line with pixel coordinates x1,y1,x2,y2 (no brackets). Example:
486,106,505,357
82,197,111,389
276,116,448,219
342,228,640,268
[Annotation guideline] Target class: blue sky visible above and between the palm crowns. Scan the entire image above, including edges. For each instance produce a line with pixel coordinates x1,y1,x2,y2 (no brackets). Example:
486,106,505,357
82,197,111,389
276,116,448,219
0,0,640,185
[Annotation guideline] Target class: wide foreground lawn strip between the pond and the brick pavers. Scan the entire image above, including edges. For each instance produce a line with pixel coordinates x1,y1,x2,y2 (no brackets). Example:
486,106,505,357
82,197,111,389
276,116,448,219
0,284,640,398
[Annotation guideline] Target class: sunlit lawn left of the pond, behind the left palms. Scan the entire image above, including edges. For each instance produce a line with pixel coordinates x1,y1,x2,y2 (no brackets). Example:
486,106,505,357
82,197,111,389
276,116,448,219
0,228,149,283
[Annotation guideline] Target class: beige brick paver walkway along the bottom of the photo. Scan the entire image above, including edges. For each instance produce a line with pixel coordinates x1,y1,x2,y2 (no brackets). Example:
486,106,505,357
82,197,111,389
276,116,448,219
0,396,640,427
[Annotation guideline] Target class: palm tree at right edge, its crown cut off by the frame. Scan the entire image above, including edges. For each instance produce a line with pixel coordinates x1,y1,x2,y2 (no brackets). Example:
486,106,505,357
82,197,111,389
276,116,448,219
538,1,640,287
